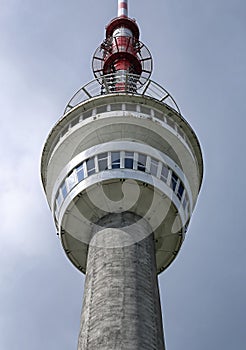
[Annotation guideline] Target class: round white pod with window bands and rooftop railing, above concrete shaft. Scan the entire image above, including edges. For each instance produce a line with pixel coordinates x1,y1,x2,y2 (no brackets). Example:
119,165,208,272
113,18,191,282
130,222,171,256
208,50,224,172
41,72,203,273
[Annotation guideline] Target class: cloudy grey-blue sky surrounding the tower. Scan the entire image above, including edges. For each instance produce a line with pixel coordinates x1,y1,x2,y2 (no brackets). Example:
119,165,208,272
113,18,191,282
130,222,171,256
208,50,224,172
0,0,246,350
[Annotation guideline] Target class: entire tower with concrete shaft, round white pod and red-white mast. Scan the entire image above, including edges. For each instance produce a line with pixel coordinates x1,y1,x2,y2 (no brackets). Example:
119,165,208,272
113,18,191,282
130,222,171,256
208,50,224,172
41,0,203,350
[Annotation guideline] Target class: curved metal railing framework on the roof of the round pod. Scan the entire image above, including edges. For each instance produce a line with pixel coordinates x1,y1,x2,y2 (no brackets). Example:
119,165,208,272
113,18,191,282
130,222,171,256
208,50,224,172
64,72,180,114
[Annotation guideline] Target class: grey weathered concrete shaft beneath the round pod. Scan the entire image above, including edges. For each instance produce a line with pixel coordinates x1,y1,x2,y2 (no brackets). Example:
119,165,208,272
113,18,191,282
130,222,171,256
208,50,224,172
78,213,164,350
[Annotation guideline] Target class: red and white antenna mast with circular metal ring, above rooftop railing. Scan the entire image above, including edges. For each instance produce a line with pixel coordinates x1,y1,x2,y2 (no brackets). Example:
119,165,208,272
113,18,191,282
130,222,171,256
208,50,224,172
92,0,152,91
